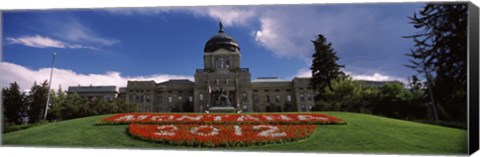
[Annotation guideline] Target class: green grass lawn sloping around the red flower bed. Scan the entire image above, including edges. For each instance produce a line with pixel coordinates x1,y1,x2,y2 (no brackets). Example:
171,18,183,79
2,112,467,154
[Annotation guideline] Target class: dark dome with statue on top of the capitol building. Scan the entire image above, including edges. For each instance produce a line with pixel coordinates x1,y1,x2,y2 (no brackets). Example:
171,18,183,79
203,22,240,52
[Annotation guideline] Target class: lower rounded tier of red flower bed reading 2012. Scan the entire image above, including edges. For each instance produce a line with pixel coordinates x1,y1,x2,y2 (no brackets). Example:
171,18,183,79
128,124,317,147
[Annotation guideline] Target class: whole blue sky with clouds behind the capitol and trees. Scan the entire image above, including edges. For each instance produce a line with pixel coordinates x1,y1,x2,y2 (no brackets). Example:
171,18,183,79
1,3,423,89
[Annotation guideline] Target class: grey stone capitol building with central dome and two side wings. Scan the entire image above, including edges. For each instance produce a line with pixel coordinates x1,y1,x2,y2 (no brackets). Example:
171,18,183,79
119,23,315,112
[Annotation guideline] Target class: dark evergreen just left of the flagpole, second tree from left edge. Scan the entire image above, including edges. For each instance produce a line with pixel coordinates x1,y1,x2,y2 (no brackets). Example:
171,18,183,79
27,80,48,123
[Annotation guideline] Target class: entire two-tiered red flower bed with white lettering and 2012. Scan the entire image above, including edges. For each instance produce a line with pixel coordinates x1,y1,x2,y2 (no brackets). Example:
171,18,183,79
97,113,345,147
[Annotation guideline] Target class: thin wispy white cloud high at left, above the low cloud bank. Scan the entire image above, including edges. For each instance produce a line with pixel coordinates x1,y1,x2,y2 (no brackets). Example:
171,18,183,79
6,34,95,49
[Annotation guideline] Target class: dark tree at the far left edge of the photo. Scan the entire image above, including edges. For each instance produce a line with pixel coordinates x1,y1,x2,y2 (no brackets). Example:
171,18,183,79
2,82,26,124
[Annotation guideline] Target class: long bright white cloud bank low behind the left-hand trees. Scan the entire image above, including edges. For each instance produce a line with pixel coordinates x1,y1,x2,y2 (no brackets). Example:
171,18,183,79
1,62,193,91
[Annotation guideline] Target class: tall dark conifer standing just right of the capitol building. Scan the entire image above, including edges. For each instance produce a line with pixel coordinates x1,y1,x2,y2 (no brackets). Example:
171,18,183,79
310,34,344,101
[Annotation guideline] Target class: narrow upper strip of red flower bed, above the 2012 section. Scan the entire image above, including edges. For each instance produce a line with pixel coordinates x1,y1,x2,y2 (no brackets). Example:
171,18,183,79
97,113,343,124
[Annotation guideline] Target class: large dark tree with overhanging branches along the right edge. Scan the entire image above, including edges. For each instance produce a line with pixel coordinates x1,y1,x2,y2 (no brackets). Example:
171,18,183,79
406,3,468,122
